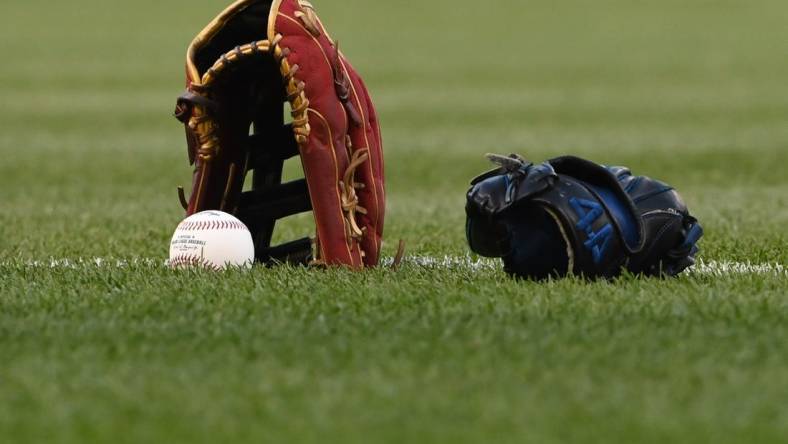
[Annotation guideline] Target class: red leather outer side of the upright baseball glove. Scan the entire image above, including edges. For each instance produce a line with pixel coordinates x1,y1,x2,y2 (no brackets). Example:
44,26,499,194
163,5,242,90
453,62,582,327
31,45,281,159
268,0,385,267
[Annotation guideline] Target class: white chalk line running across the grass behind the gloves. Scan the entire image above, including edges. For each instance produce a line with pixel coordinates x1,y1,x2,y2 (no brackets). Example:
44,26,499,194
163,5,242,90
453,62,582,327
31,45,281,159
0,255,788,277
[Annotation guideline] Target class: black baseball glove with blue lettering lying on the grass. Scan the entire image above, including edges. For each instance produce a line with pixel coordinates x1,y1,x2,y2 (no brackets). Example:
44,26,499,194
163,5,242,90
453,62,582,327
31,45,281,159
466,154,703,279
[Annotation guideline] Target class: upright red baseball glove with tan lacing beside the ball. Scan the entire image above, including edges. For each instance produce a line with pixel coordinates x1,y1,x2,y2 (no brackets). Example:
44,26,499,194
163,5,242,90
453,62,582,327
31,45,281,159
175,0,385,269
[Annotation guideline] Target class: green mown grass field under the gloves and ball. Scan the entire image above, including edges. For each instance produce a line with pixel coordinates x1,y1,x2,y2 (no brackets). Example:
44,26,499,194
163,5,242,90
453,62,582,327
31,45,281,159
0,0,788,443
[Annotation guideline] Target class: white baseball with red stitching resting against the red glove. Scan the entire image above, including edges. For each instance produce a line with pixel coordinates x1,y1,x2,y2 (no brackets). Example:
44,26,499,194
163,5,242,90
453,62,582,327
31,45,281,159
168,211,254,270
